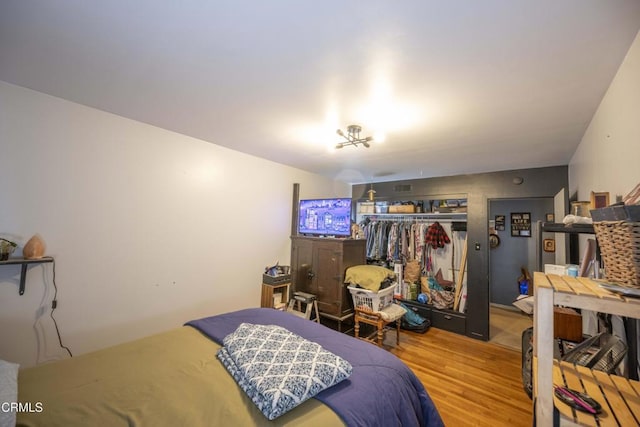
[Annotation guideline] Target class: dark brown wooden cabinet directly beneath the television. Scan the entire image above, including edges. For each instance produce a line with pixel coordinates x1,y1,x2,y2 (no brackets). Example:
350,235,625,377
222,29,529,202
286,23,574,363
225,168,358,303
291,236,366,317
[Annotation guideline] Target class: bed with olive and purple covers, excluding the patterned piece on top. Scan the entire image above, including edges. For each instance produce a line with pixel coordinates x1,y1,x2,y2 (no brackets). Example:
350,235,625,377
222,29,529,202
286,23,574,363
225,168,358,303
17,308,443,427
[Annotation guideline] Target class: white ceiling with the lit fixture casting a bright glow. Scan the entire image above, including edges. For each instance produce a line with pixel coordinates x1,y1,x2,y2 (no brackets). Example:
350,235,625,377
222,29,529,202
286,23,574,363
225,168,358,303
0,0,640,183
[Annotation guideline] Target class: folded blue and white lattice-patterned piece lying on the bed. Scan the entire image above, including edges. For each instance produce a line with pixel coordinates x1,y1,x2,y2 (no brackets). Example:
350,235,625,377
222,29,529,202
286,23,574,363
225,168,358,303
218,323,352,420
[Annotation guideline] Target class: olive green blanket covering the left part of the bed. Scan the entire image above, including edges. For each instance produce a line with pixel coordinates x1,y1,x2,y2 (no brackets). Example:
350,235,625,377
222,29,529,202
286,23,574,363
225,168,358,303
17,326,343,427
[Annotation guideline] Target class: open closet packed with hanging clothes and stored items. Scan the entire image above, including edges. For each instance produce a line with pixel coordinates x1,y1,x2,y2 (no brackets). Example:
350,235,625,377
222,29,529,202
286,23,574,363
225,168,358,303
356,199,466,334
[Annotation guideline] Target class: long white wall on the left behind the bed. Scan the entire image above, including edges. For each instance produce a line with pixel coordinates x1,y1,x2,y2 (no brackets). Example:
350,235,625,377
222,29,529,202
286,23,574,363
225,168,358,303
0,82,351,366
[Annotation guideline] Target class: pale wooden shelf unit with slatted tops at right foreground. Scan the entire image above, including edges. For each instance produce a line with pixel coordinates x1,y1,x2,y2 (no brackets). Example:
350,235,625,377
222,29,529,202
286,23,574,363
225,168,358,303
533,272,640,426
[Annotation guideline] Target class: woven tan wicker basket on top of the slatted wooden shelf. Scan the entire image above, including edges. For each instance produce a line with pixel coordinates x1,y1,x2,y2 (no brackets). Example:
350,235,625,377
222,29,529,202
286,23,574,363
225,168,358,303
593,221,640,288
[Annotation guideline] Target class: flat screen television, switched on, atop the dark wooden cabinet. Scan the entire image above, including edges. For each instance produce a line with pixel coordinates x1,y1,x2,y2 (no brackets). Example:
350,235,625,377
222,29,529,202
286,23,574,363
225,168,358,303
298,198,351,237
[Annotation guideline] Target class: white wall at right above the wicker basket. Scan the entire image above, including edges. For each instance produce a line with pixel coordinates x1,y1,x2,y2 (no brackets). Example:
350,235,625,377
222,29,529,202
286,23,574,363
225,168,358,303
569,33,640,203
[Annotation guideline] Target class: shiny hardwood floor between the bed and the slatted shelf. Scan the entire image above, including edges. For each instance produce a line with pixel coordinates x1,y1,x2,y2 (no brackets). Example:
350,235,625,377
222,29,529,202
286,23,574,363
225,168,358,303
385,328,533,427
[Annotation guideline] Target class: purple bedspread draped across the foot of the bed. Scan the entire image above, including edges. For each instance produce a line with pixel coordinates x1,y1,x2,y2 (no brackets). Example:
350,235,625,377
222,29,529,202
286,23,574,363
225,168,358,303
187,308,444,427
